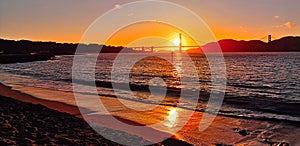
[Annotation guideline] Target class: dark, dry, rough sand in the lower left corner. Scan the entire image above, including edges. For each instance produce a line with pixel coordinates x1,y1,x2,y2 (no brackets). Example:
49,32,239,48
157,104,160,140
0,96,125,145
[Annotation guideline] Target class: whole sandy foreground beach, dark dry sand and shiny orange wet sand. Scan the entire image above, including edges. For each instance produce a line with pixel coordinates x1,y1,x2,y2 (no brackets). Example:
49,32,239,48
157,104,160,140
0,82,300,146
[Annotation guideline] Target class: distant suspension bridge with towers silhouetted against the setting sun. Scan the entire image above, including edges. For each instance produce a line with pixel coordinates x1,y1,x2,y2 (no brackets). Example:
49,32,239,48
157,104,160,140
127,33,276,53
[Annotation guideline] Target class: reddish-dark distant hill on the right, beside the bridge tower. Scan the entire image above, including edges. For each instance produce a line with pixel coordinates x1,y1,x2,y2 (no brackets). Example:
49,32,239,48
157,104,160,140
187,36,300,53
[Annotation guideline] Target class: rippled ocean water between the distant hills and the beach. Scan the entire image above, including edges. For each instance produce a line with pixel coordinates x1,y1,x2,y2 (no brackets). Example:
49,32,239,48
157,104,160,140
0,53,300,122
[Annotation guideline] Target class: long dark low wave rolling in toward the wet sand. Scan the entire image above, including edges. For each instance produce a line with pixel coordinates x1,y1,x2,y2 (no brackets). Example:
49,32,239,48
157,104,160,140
73,80,300,122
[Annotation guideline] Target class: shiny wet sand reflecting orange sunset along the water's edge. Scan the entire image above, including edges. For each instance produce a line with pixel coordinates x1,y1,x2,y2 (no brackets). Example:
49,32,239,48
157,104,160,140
0,82,300,146
